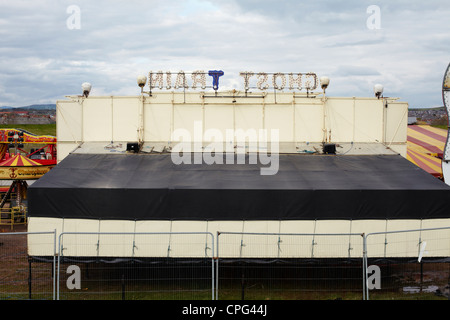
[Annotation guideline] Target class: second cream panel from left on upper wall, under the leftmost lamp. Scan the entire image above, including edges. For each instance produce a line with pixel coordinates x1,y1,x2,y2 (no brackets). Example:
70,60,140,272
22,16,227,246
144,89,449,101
82,98,113,141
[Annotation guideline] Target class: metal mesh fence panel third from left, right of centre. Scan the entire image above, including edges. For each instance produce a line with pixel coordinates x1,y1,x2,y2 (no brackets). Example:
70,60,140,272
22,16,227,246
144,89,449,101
216,232,364,300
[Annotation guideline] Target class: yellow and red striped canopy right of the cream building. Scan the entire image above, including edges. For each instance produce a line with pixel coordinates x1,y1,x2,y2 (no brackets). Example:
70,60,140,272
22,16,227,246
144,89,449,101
407,125,447,177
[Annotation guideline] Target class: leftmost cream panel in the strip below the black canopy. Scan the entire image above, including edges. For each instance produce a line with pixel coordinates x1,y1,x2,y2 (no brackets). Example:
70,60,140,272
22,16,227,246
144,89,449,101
27,217,63,256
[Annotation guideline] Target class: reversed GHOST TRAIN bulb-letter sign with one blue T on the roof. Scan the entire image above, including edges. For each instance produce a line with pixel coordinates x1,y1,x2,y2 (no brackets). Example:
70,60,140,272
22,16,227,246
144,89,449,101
145,70,319,92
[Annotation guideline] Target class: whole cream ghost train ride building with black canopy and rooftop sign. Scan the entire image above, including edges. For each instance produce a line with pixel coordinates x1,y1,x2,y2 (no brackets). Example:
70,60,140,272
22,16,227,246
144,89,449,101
28,70,450,259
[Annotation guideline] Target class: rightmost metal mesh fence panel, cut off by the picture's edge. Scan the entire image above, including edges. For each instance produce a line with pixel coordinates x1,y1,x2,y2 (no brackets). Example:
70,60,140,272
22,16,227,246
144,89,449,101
364,227,450,299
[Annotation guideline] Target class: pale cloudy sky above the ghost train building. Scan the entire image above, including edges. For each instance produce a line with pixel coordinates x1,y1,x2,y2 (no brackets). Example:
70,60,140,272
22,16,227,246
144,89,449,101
0,0,450,107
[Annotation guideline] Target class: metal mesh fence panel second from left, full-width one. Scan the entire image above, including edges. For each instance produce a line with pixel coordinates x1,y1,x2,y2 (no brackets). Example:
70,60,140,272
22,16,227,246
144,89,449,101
57,232,215,300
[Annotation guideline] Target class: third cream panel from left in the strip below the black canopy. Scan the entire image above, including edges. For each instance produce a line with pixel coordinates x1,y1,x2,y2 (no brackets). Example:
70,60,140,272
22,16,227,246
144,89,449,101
99,220,135,257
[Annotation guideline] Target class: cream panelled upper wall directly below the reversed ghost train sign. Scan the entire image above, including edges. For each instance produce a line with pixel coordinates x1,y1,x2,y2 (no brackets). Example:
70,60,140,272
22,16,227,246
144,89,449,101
57,92,407,148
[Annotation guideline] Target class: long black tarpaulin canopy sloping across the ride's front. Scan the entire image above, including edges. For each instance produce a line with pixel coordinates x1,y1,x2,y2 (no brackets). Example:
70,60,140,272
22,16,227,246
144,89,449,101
28,154,450,220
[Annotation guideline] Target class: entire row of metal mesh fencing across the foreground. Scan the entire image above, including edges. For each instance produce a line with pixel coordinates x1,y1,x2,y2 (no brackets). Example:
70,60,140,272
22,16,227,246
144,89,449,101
0,227,450,300
